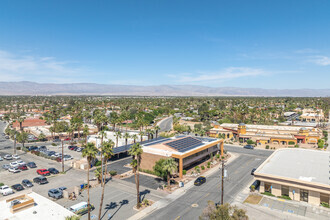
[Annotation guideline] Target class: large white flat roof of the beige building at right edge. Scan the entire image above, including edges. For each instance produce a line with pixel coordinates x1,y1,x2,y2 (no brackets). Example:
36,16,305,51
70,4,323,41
255,148,330,186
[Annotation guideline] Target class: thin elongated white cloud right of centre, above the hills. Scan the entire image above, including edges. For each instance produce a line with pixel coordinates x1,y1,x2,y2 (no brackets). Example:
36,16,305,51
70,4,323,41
168,67,269,83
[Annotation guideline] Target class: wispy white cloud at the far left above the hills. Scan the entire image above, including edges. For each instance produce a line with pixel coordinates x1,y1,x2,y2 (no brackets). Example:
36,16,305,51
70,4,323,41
0,50,89,83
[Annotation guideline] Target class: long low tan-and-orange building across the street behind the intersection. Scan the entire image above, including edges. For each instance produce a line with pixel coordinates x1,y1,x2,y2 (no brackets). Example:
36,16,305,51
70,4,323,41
210,123,322,145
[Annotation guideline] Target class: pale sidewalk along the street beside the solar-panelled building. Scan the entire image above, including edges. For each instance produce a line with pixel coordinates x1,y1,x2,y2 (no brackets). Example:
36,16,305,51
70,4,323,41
128,153,237,220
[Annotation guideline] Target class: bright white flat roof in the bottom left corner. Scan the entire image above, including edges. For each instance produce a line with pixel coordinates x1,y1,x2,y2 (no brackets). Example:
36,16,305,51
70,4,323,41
0,192,74,220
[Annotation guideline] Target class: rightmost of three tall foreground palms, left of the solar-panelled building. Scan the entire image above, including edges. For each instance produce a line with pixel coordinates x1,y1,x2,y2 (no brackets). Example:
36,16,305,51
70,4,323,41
128,143,143,208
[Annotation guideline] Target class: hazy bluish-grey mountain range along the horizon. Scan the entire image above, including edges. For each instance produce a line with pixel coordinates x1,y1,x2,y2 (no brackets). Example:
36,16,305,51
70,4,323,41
0,81,330,97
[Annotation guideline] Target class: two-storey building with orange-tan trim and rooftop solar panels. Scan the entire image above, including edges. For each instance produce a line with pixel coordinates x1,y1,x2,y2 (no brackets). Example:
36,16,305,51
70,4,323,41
141,136,223,178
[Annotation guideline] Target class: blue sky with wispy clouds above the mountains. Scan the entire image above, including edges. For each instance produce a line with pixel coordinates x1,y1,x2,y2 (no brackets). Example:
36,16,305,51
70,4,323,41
0,0,330,89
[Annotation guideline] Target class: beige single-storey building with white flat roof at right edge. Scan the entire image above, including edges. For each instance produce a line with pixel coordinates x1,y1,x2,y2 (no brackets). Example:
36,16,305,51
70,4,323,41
254,148,330,205
